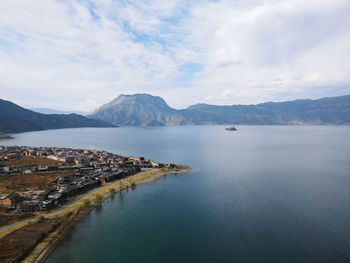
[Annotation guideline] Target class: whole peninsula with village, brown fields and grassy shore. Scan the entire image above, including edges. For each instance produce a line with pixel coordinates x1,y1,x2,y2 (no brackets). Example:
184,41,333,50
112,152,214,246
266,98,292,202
0,146,190,262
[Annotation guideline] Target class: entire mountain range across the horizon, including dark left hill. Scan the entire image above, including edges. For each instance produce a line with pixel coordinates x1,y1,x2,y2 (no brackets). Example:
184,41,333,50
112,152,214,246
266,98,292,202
0,94,350,134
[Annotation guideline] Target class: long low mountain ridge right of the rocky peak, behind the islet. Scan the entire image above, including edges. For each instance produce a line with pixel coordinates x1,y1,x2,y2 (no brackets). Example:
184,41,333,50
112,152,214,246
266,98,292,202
187,96,350,124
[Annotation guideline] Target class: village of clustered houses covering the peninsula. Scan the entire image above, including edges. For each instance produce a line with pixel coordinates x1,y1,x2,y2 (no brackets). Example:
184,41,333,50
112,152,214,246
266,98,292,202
0,146,170,212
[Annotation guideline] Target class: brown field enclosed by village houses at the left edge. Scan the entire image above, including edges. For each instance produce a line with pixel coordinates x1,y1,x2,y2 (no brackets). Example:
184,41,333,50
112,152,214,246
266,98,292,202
0,171,74,195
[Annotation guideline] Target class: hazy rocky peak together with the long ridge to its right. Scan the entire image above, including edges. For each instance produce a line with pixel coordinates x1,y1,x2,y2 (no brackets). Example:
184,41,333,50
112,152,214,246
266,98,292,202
87,94,350,125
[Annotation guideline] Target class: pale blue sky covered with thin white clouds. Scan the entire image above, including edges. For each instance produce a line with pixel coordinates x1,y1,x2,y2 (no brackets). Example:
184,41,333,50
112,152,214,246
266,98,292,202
0,0,350,111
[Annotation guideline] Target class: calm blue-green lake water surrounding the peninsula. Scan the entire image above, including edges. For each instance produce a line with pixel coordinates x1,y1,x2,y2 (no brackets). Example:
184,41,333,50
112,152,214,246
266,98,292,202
2,126,350,262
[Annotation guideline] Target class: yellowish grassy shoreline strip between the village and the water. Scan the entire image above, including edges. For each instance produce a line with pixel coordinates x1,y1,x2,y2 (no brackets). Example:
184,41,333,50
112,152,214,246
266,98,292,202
21,165,191,263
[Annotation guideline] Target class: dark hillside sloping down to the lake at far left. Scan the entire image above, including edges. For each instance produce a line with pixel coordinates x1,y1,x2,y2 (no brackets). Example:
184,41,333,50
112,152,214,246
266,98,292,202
0,99,113,133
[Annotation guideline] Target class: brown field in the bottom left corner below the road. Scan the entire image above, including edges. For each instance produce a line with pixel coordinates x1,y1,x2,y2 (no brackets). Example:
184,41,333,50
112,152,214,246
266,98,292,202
0,218,58,263
